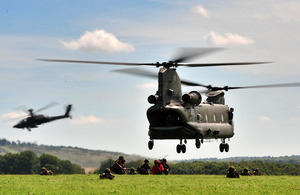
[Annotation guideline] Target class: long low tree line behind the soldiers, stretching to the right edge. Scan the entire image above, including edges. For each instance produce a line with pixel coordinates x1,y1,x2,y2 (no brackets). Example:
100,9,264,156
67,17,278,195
94,159,300,175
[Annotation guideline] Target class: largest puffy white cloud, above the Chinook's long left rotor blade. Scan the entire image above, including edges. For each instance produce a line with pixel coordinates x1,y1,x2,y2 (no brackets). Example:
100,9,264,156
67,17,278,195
61,30,134,53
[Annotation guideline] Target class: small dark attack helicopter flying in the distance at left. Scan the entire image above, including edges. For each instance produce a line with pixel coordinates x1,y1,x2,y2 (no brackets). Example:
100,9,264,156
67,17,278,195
13,103,72,131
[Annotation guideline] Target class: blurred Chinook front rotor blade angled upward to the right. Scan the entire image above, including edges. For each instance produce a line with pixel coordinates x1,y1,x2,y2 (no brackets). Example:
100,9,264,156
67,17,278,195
170,47,223,63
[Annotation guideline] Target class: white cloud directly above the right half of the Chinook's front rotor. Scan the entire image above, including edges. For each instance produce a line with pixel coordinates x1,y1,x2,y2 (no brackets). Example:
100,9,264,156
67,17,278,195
204,31,254,45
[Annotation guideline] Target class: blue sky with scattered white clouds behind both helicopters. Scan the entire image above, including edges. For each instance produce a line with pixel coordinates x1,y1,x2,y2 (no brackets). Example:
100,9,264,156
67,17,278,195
0,0,300,160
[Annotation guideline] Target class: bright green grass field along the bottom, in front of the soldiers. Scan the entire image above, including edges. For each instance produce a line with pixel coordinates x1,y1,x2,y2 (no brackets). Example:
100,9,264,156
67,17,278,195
0,175,300,194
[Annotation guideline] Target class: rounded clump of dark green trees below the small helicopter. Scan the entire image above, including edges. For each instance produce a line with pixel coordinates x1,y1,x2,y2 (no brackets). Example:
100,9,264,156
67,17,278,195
0,151,85,174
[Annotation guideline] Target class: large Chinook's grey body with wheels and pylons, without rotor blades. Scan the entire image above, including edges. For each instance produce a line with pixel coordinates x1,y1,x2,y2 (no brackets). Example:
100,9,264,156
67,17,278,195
147,67,234,153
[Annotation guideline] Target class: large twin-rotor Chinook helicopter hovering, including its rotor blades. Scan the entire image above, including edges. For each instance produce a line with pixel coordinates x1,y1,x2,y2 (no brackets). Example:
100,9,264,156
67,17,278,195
39,48,300,153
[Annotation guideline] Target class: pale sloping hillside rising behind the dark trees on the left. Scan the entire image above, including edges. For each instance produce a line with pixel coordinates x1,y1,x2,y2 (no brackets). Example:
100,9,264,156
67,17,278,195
0,139,145,170
